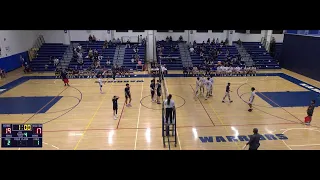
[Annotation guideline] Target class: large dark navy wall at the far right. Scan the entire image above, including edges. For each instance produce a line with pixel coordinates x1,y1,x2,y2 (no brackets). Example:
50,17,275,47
280,34,320,81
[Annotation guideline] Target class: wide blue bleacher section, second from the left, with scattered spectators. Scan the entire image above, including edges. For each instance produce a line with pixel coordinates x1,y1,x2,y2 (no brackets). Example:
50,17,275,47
69,41,116,69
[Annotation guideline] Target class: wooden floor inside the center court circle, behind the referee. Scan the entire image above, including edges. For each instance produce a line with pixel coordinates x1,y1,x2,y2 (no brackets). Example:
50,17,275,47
140,94,186,110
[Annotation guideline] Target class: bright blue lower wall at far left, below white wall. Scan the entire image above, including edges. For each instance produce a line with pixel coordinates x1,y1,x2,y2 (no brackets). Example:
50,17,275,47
0,51,29,72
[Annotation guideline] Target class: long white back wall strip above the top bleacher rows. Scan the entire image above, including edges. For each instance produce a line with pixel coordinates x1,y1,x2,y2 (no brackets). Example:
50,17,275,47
41,30,283,43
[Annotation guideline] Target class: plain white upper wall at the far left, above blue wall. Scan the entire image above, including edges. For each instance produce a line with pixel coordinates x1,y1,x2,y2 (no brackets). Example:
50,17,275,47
0,30,39,57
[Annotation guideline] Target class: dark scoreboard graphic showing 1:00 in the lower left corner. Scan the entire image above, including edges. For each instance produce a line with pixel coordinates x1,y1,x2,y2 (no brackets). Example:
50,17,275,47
1,124,42,148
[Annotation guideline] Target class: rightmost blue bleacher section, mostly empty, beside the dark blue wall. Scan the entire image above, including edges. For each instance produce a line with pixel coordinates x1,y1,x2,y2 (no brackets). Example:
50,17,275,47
242,42,280,69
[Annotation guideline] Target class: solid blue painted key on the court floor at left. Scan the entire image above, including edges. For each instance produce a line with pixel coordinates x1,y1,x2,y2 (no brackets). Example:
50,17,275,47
0,96,62,114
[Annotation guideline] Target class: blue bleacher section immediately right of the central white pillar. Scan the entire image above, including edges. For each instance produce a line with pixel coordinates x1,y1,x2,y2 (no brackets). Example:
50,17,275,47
157,41,182,70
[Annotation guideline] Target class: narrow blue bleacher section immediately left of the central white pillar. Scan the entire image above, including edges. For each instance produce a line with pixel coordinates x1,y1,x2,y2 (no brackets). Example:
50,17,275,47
123,44,146,70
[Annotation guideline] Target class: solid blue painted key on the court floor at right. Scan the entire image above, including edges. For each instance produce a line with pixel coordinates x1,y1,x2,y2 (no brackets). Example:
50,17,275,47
256,91,320,107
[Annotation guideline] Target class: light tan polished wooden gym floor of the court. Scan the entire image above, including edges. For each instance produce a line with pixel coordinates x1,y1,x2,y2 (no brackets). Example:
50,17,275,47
0,70,320,150
